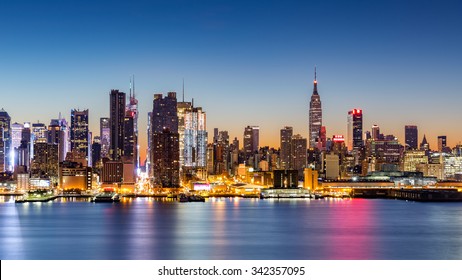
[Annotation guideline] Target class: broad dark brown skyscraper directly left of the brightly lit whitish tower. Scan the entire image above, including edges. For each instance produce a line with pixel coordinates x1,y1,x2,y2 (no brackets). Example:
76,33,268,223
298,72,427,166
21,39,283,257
150,92,180,187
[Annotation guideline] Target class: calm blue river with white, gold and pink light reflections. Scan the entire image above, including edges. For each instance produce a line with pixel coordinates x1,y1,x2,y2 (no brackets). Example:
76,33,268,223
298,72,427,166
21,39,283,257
0,198,462,260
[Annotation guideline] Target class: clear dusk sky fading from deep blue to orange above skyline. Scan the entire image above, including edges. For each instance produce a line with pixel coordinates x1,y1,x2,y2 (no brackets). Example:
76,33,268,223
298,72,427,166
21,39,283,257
0,0,462,161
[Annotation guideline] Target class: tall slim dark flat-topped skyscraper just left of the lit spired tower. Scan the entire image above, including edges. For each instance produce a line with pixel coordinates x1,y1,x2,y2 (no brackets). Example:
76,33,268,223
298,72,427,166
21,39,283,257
109,89,125,160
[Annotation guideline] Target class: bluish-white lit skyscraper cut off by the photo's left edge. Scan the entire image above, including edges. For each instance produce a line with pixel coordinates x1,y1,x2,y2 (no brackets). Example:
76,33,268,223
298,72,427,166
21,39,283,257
0,108,13,172
